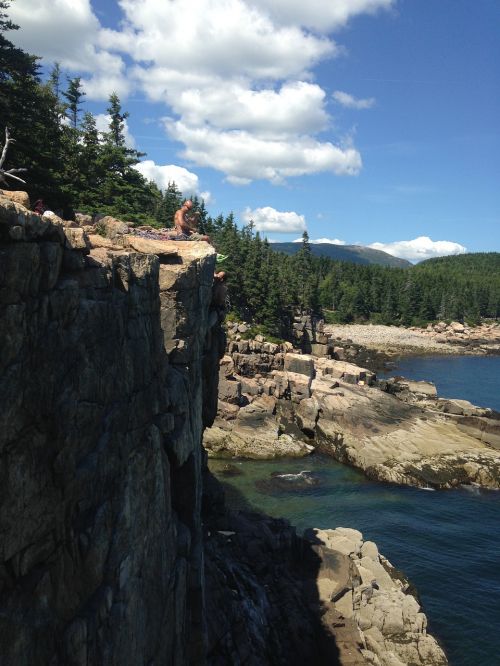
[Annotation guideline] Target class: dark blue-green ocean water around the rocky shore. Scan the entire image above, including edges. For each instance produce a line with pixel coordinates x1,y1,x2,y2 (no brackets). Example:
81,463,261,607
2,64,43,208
210,357,500,666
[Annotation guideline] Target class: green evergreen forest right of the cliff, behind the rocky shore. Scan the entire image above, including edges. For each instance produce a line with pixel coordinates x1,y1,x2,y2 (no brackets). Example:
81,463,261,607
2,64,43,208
204,215,500,337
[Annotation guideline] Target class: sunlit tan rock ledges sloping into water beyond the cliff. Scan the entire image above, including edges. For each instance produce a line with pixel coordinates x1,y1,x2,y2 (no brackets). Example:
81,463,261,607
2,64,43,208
204,326,500,489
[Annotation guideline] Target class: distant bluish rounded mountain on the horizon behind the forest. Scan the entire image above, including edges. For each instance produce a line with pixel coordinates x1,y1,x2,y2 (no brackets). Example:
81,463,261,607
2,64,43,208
271,243,412,268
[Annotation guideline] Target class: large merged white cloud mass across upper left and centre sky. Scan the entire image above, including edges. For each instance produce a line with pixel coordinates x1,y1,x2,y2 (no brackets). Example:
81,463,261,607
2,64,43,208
5,0,395,184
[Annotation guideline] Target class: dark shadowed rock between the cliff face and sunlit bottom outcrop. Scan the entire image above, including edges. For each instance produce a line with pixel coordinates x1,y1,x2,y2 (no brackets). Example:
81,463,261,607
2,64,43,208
204,471,342,666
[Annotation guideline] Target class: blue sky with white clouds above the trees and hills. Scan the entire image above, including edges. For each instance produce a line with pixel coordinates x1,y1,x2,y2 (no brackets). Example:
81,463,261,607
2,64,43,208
4,0,500,262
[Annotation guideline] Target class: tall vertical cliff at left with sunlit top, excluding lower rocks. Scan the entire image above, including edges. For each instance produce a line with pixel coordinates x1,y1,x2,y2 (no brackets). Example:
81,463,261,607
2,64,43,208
0,197,220,665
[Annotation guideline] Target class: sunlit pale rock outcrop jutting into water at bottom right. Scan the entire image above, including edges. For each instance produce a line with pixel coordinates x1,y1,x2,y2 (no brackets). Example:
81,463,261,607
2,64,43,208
310,527,448,666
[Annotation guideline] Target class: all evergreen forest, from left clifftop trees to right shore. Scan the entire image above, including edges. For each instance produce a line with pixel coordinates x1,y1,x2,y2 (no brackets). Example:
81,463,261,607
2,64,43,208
0,0,500,336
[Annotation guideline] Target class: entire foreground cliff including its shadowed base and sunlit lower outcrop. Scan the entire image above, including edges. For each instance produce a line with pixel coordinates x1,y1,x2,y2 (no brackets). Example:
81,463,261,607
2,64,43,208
0,196,446,666
